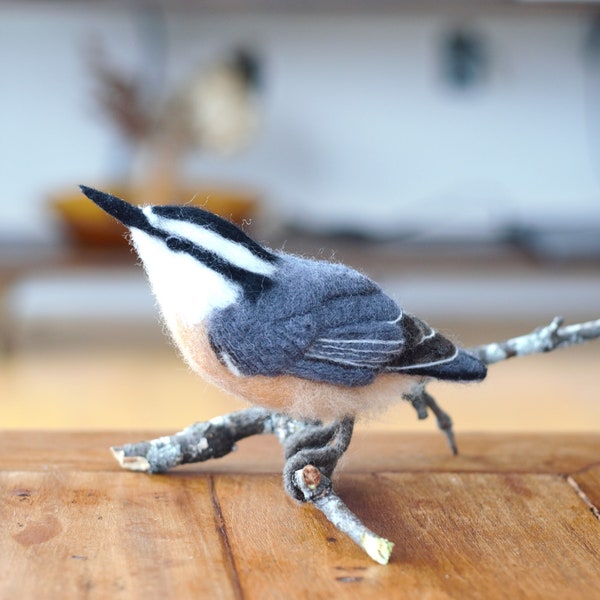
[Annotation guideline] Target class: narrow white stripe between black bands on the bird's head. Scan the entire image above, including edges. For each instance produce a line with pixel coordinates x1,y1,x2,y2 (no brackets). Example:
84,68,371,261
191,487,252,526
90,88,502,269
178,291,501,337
143,206,275,275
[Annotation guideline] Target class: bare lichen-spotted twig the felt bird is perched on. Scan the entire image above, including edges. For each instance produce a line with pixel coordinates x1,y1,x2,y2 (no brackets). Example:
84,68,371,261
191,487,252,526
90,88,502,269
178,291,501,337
111,317,600,564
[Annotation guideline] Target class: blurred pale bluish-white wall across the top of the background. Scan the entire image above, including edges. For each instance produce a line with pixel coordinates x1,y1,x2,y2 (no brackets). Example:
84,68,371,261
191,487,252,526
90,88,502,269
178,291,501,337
0,2,600,239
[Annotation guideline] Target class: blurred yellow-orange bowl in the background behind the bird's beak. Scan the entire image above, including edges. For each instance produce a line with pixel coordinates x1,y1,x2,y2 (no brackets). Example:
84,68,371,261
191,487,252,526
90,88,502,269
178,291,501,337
50,185,258,247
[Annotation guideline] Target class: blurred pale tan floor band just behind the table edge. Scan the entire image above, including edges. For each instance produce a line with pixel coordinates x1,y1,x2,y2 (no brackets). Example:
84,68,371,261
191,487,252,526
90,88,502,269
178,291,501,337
0,323,600,433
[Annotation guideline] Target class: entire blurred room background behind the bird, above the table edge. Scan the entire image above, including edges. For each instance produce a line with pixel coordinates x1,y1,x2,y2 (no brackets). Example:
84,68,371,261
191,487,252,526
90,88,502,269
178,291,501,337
0,0,600,432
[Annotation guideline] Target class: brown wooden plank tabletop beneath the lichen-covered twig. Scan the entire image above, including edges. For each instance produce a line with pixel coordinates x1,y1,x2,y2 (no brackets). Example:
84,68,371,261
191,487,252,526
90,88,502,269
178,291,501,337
0,431,600,600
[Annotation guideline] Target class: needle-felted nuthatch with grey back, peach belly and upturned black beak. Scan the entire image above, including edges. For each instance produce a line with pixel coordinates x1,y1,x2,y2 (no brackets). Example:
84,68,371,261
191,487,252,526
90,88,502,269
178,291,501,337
81,186,486,419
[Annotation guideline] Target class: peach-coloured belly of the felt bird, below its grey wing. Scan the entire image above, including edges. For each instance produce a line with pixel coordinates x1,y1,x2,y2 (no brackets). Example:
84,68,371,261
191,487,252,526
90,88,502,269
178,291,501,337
170,322,419,420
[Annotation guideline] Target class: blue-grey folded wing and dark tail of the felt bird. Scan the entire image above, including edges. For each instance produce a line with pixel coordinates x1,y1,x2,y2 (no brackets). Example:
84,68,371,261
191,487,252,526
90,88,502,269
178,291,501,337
209,258,482,387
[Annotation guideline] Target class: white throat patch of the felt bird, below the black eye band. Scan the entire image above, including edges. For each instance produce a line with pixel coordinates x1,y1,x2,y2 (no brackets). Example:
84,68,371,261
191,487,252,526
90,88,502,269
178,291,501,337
131,228,242,327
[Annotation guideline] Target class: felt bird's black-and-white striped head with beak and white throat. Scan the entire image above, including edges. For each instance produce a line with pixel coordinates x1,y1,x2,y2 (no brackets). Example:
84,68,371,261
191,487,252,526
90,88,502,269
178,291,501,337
81,186,278,323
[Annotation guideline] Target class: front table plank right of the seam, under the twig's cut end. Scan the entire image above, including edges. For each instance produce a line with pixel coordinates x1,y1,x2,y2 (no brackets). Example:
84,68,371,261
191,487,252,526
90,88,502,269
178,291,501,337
216,473,600,599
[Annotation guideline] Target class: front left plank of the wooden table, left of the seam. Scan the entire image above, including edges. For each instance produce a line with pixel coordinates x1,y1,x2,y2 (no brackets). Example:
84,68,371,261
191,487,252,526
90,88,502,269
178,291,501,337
0,471,235,600
